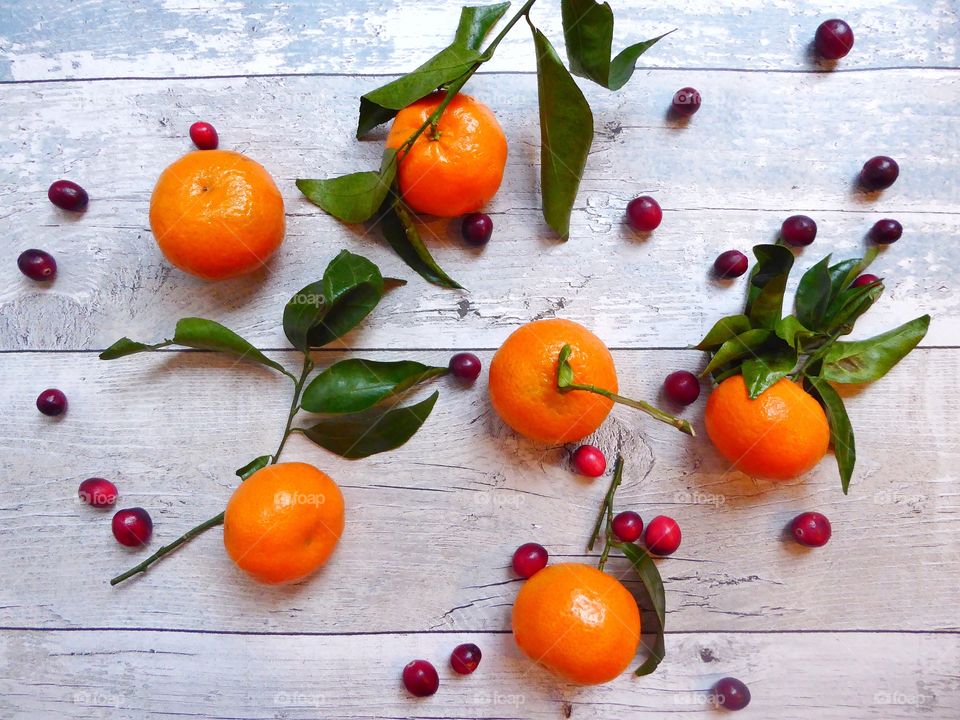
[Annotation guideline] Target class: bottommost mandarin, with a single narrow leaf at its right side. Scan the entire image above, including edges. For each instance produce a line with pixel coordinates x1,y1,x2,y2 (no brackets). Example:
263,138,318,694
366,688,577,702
512,563,640,685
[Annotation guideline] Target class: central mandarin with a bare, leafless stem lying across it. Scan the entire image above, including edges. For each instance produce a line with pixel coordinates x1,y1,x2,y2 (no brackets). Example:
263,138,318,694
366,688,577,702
489,318,618,444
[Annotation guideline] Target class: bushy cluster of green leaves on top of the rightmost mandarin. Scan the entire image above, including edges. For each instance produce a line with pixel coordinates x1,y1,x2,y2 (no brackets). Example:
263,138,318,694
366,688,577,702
696,245,930,494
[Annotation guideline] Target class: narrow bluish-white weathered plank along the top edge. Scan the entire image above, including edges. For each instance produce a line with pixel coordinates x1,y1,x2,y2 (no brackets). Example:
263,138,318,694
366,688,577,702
0,0,960,80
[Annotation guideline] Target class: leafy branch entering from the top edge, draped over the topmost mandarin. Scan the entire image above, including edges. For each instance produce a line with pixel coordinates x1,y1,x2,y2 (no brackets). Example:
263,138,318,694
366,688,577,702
297,0,665,288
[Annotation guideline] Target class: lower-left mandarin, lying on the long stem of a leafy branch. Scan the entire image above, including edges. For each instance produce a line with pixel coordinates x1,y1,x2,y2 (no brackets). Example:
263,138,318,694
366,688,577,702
223,463,343,585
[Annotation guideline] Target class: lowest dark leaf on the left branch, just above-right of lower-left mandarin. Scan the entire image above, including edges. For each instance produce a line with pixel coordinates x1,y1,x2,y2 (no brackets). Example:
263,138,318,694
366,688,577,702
300,392,440,460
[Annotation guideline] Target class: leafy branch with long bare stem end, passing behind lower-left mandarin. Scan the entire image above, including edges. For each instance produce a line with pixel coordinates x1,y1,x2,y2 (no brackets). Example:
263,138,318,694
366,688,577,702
100,251,448,585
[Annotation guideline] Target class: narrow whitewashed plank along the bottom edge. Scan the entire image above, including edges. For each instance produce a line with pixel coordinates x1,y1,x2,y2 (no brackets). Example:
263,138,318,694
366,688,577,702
0,631,960,720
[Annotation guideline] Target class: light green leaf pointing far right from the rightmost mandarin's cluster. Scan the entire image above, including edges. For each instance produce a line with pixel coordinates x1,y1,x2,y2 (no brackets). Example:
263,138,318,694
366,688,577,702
820,315,930,383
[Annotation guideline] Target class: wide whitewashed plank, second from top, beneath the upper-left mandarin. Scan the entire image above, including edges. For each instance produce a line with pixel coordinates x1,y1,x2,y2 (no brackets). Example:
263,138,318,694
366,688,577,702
0,70,960,349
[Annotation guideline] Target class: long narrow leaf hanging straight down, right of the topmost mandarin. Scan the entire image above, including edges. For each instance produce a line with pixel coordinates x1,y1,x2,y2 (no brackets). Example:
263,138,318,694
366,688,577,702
528,18,593,240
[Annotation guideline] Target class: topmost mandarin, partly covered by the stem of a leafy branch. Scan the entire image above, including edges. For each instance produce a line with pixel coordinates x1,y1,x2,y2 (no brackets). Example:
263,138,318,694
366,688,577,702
387,92,507,217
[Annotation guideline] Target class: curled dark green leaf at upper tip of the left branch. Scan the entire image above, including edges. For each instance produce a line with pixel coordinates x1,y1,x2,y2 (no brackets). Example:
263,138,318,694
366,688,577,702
283,250,384,352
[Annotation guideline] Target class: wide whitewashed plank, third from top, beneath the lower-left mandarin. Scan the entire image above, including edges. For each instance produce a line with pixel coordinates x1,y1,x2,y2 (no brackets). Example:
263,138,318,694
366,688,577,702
0,350,960,632
